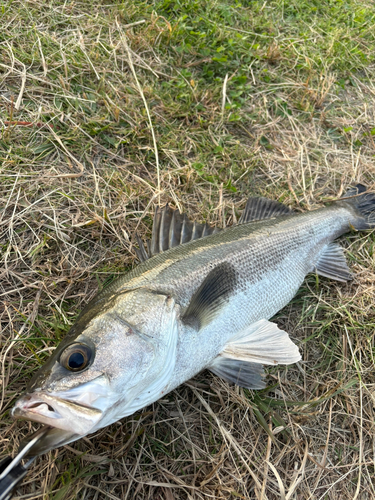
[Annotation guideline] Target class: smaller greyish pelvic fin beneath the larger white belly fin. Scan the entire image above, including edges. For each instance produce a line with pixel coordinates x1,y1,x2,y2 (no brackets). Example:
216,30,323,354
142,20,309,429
208,356,266,389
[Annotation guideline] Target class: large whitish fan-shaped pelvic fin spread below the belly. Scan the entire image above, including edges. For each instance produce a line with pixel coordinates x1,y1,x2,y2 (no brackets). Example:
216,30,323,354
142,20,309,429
221,319,301,365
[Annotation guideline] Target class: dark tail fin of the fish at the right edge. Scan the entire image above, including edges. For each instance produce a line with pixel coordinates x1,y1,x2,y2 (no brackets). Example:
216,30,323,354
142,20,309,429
341,184,375,230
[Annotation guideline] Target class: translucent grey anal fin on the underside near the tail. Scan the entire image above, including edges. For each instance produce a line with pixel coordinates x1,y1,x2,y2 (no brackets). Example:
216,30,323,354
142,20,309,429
314,242,353,282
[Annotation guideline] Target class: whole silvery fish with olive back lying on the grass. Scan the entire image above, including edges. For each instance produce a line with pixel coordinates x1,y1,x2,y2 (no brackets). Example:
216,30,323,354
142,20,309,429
12,184,375,456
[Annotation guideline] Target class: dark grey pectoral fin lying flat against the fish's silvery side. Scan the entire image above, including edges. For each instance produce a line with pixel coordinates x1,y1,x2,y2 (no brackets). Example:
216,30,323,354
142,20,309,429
181,262,238,330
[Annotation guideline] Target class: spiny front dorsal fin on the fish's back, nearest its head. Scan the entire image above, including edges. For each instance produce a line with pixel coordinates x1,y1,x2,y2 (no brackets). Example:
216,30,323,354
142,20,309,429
135,205,221,262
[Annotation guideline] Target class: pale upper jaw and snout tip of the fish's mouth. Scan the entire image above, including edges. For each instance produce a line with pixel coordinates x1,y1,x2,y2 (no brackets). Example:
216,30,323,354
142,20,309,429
12,392,103,436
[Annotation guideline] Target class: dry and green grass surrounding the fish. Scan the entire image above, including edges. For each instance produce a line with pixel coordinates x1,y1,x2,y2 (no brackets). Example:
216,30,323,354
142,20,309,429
0,0,375,500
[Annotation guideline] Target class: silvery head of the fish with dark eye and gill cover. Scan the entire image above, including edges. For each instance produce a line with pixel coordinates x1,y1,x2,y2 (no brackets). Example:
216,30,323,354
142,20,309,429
12,289,177,455
